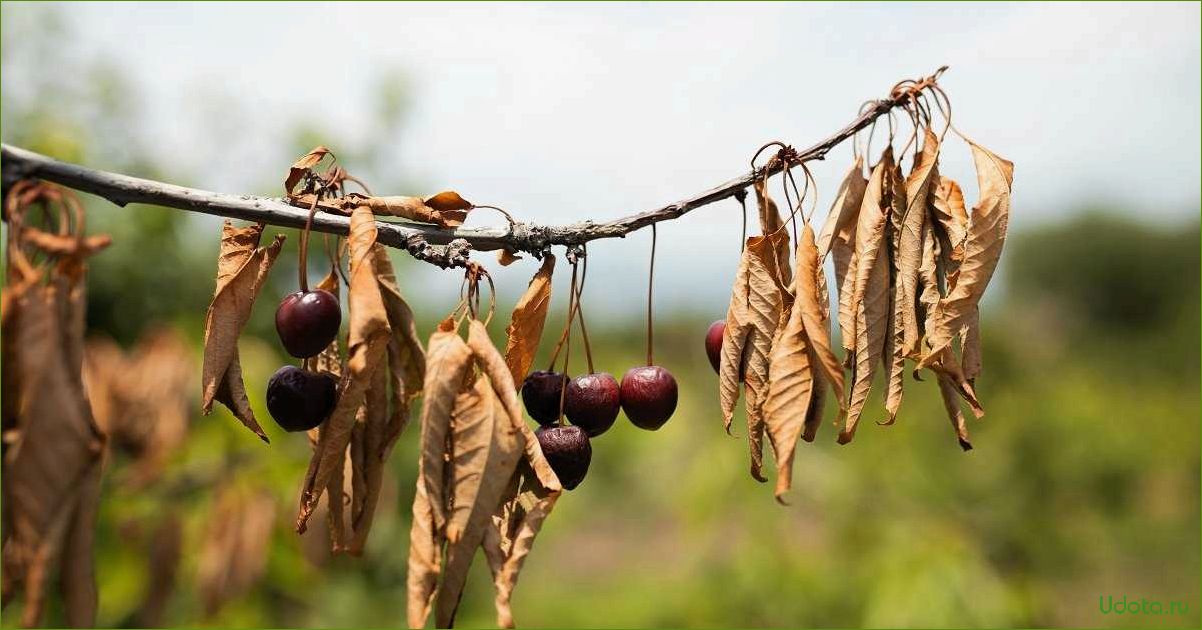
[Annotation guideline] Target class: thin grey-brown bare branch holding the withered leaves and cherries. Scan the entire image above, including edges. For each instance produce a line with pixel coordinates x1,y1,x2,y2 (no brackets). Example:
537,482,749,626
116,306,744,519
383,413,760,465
0,69,942,267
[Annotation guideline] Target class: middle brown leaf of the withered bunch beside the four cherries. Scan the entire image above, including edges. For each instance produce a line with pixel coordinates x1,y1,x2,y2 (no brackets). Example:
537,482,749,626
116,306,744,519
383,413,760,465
434,379,523,628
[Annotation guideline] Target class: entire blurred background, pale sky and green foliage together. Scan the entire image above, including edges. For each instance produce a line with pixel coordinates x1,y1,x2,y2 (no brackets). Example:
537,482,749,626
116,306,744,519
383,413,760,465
2,2,1202,628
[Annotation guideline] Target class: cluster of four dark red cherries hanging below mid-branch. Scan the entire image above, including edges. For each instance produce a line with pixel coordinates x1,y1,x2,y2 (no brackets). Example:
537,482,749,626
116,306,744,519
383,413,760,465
522,358,677,489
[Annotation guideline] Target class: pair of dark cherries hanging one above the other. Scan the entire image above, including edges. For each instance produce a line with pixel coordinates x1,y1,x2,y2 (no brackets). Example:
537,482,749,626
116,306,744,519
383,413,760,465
267,289,343,432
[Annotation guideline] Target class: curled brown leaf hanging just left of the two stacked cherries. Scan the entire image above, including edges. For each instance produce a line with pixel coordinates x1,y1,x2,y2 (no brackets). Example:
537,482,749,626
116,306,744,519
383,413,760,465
201,221,284,442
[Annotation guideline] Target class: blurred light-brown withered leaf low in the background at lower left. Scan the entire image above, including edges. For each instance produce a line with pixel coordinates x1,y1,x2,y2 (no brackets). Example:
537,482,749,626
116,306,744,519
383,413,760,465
196,487,275,617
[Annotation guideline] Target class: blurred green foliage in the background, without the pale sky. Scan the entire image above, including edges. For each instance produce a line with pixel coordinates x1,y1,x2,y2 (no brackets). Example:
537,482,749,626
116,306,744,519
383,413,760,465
2,5,1200,628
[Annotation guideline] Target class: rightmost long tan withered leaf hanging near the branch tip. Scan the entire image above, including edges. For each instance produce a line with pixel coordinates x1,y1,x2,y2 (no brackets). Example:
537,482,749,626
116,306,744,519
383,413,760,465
918,142,1014,406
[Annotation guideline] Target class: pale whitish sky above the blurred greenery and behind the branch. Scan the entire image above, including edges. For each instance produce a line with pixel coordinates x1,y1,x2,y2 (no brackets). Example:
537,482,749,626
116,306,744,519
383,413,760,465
4,2,1202,319
